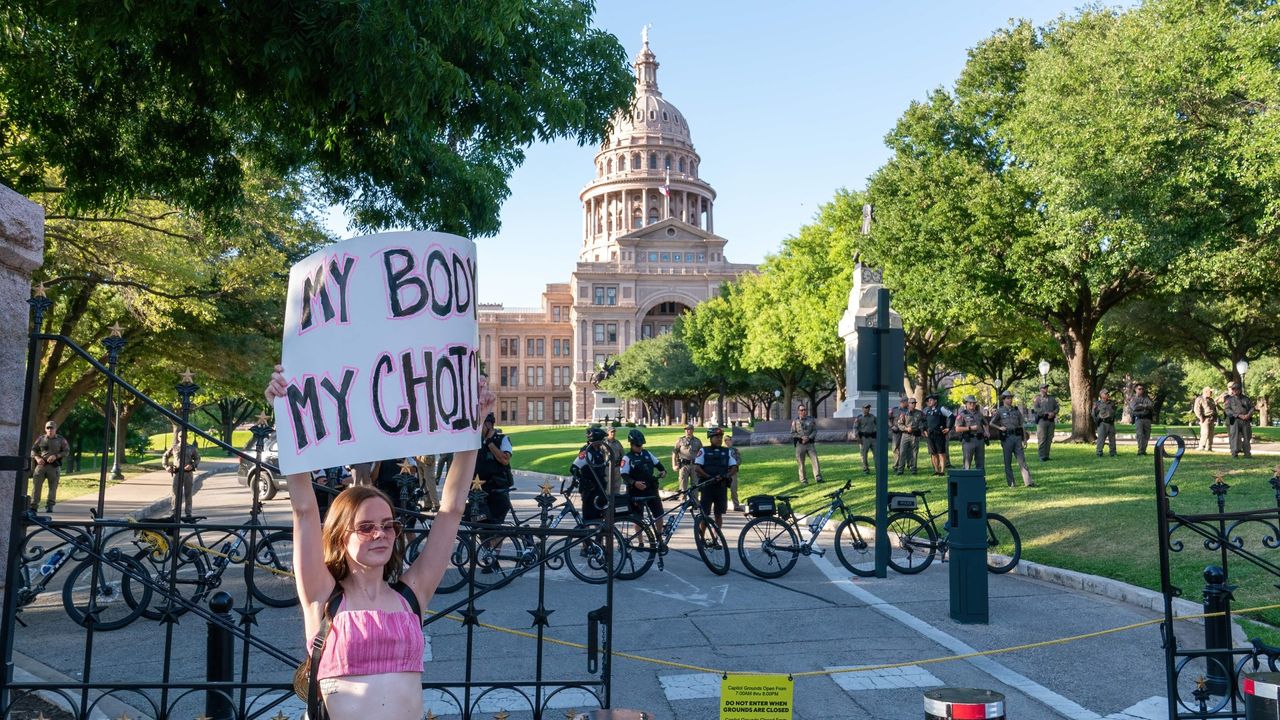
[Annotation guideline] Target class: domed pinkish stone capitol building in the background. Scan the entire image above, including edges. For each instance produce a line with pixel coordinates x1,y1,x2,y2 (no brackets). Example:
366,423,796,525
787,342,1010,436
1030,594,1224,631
480,33,756,424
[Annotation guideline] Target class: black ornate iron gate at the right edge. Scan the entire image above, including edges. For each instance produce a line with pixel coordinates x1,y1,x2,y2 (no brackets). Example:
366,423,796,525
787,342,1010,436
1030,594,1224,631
1156,436,1280,720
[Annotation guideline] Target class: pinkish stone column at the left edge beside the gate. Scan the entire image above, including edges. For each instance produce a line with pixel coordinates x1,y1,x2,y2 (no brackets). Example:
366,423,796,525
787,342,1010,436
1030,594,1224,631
0,184,45,588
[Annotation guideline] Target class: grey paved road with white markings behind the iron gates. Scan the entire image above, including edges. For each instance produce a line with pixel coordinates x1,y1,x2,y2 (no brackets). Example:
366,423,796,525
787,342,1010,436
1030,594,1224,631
15,461,1187,720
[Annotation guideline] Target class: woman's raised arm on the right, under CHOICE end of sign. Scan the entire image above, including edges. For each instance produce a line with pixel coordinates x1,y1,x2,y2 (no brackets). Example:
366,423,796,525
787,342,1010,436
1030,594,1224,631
401,375,502,609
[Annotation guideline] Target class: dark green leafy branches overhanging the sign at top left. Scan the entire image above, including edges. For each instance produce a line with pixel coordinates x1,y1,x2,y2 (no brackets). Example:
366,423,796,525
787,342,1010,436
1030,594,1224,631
0,0,632,236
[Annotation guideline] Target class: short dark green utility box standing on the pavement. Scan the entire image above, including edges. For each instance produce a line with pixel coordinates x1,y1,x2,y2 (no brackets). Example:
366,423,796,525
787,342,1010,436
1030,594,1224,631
945,469,991,625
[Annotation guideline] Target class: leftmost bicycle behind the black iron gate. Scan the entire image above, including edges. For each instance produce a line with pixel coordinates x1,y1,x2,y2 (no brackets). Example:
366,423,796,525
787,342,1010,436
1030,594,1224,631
17,527,151,630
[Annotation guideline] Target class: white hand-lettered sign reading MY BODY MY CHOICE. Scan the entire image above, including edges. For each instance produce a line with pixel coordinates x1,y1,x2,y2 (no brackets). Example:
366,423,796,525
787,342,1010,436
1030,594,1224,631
275,232,483,473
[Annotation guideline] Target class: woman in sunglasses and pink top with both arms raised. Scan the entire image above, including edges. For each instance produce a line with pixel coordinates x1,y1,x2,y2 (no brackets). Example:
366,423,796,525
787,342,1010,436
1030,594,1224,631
266,365,494,720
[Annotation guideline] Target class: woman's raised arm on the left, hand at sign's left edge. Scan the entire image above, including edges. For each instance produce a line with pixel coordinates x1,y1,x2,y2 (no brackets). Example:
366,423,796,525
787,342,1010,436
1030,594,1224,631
266,365,335,617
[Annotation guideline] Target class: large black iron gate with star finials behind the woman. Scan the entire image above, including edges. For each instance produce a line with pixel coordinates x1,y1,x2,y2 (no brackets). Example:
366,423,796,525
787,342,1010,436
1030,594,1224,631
0,297,621,720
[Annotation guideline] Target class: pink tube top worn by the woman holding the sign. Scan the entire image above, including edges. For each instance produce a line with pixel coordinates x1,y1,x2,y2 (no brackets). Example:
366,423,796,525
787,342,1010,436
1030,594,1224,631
316,589,425,679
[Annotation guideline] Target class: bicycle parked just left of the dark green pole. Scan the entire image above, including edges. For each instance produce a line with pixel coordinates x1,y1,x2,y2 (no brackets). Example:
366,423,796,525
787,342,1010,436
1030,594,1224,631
737,479,876,579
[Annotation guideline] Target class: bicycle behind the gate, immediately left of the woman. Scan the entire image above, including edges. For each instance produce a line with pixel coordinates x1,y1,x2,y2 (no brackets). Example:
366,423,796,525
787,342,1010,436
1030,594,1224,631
123,516,298,620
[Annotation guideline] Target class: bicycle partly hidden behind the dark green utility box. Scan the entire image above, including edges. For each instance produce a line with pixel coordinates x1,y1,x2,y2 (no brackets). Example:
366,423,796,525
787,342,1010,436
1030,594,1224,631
888,491,1023,575
